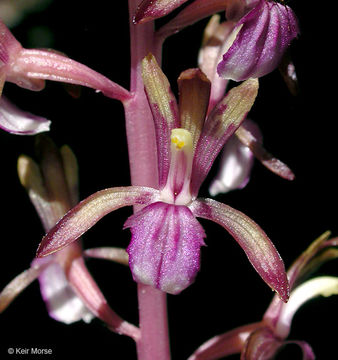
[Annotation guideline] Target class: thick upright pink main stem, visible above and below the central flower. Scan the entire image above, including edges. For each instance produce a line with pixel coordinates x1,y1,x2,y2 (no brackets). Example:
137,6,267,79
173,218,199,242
124,0,170,360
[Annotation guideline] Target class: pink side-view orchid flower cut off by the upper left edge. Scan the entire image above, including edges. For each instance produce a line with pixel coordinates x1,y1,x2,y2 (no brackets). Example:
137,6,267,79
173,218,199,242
0,20,130,134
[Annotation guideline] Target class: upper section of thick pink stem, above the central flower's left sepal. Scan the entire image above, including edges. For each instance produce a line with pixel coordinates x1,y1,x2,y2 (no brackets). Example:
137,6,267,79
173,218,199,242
124,0,158,188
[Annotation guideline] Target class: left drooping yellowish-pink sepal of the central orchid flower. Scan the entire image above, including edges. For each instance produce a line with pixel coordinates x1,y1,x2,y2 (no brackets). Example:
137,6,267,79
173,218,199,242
37,186,158,257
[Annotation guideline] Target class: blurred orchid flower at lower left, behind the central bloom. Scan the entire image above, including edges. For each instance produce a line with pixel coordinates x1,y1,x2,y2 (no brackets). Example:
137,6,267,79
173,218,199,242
0,137,138,339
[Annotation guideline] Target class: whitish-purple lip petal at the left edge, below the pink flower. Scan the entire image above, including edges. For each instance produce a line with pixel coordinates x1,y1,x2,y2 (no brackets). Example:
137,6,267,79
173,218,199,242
0,97,51,135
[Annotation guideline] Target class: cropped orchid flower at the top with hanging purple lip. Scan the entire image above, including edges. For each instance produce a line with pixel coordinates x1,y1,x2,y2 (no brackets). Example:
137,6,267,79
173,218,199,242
134,0,299,81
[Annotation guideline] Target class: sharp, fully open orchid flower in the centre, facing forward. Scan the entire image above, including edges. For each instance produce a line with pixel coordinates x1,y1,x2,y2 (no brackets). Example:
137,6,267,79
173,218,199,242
37,54,288,301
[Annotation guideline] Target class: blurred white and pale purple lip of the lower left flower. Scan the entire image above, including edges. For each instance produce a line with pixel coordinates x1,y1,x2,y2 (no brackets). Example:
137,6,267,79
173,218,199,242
38,259,93,324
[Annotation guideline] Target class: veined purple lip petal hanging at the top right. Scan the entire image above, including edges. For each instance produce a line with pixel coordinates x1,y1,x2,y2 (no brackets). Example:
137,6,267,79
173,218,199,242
218,0,299,81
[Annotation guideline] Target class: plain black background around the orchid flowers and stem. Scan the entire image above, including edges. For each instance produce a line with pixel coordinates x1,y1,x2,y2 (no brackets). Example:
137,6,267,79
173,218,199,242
0,0,338,359
